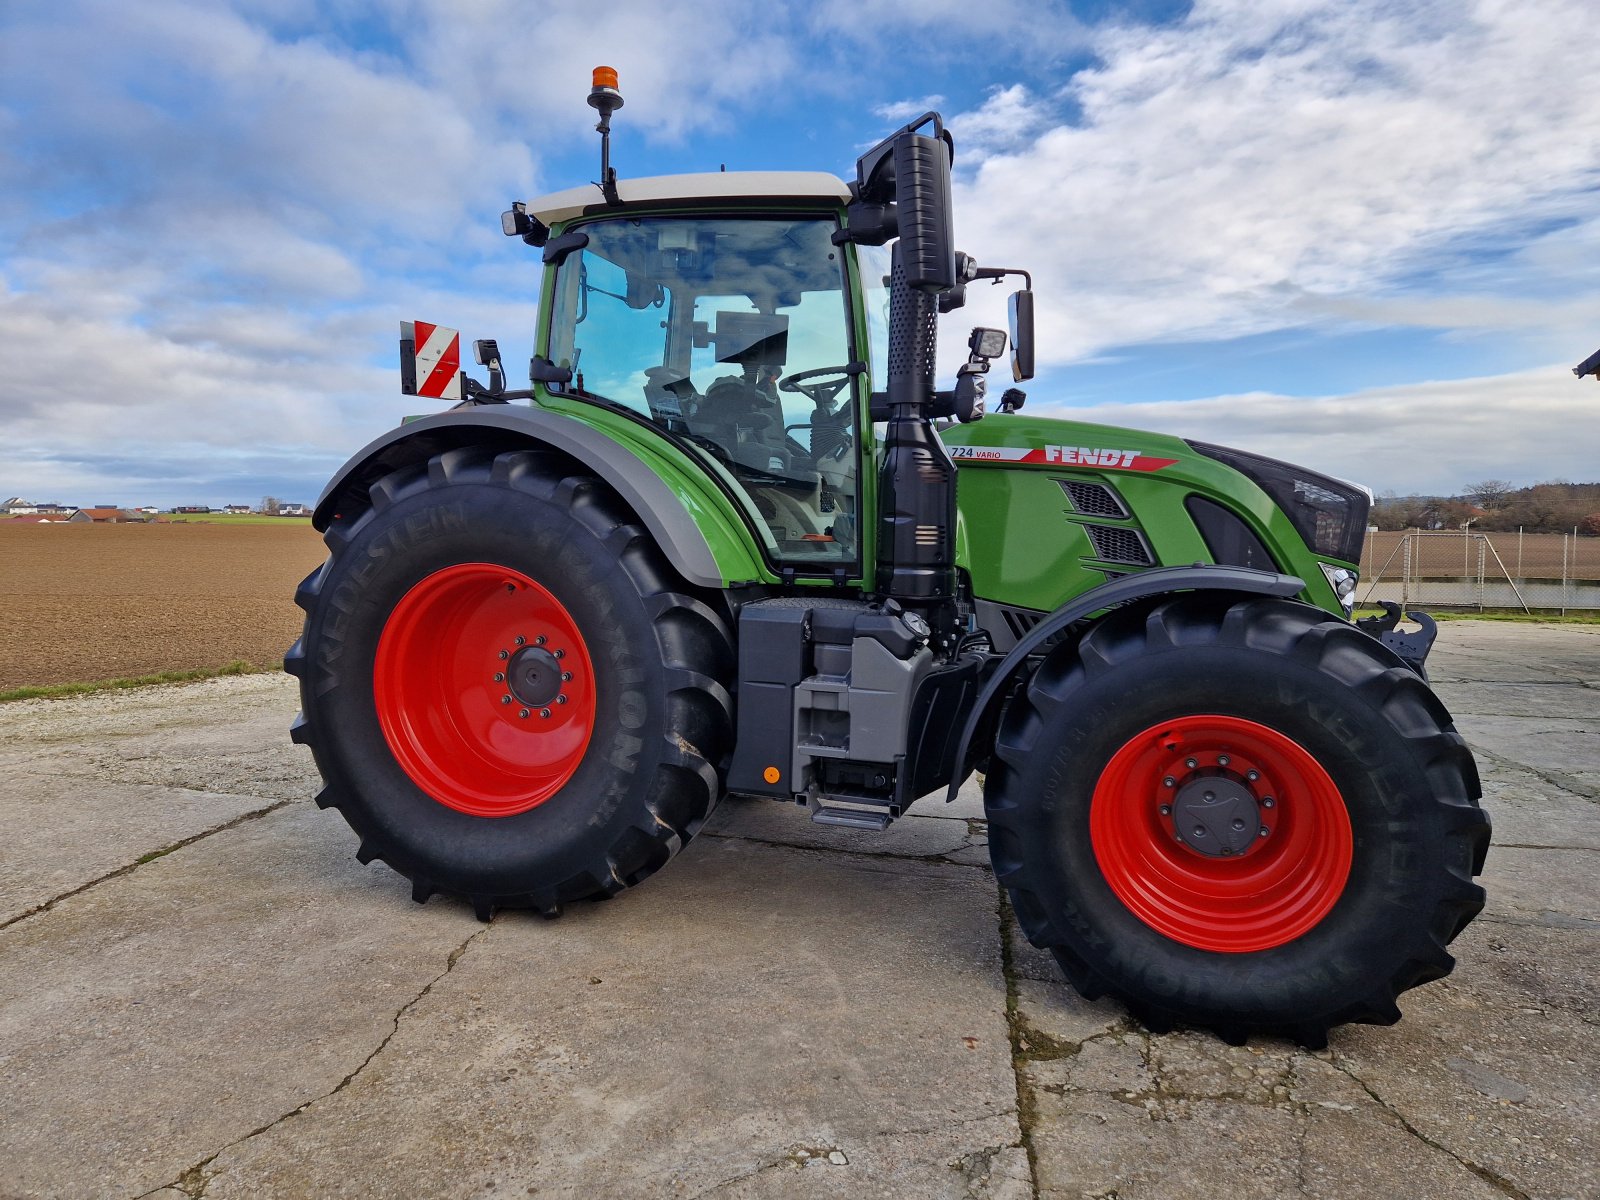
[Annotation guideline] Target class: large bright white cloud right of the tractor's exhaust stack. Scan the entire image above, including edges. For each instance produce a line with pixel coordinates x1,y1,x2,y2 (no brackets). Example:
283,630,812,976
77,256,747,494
949,0,1600,363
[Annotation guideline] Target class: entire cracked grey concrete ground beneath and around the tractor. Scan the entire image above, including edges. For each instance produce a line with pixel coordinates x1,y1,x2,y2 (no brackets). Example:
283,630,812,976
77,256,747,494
0,622,1600,1200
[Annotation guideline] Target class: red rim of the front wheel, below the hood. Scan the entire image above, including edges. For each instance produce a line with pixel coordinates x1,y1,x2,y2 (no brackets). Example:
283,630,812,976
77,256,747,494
1090,714,1354,954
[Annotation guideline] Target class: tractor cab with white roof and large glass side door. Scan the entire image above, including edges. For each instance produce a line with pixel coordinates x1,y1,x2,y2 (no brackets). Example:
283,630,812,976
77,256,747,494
528,188,886,570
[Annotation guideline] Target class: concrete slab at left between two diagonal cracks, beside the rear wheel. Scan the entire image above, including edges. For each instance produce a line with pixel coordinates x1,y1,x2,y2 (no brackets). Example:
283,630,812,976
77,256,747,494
0,805,472,1195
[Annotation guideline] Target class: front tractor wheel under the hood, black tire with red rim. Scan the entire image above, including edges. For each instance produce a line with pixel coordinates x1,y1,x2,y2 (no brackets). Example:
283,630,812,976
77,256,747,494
986,594,1490,1048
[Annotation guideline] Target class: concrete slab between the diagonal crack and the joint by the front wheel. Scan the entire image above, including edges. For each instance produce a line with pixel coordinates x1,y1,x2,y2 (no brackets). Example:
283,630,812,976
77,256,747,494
178,838,1029,1200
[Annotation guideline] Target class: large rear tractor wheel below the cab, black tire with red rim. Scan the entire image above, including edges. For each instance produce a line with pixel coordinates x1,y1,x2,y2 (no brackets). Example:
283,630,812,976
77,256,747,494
283,448,733,920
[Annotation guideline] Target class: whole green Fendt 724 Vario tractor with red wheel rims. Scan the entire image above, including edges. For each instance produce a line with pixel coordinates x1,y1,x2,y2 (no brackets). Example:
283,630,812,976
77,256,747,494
285,72,1490,1046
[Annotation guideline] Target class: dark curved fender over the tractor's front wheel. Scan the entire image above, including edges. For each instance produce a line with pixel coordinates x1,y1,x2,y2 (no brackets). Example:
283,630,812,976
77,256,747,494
944,563,1306,803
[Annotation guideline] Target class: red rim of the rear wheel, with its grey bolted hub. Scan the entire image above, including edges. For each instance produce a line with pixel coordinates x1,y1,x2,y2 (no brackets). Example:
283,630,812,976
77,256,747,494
373,563,595,816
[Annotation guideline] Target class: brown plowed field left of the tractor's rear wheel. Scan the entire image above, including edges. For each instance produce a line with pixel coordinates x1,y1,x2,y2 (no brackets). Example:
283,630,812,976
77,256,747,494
0,518,323,691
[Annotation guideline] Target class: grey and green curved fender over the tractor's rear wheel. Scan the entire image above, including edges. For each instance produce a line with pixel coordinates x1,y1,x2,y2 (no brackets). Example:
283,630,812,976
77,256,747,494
312,405,768,589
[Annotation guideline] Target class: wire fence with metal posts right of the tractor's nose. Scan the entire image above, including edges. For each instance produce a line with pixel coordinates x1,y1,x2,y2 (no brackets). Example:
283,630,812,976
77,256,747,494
1360,530,1600,613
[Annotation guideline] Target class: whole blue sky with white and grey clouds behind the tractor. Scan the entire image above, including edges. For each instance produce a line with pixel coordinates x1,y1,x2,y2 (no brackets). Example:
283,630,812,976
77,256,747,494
0,0,1600,507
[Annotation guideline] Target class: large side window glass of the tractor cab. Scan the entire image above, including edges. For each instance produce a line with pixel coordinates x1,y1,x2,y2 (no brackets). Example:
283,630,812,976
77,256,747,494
550,218,858,562
